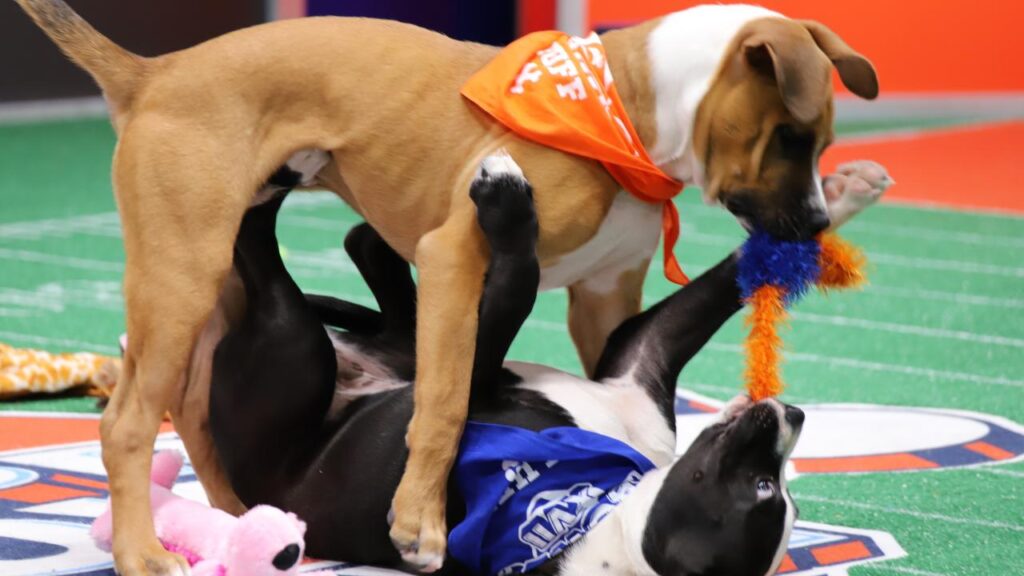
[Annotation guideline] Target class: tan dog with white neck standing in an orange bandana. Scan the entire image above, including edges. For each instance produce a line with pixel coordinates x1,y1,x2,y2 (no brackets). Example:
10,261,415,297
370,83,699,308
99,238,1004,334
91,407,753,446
17,0,878,575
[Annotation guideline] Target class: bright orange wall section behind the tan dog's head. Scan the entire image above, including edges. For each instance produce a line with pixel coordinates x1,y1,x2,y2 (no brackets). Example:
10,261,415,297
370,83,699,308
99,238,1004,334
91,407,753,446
584,0,1024,93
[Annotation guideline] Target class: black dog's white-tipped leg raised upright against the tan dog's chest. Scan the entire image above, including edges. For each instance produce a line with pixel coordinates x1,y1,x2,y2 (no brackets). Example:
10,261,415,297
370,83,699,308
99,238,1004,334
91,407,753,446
469,152,541,386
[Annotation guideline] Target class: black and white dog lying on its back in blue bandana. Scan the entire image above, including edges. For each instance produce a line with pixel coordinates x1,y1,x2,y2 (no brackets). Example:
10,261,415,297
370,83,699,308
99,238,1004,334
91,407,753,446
210,156,888,576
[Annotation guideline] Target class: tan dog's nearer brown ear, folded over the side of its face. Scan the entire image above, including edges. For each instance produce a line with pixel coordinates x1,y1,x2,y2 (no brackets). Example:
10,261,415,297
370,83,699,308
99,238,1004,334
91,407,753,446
742,18,831,124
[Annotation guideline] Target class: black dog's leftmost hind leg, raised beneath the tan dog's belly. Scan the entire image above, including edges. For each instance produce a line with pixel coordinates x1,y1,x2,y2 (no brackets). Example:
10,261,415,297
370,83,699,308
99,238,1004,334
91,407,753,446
210,193,337,505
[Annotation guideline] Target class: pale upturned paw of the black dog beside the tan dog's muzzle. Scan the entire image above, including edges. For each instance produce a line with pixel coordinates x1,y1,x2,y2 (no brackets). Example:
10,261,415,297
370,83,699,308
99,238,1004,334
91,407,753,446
822,160,895,230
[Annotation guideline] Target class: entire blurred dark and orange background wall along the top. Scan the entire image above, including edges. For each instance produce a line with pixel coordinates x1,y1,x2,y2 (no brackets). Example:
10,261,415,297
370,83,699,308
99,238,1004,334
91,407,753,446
0,0,1024,118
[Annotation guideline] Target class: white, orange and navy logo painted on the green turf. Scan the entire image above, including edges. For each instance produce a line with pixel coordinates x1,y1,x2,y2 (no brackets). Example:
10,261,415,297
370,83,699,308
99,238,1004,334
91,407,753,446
0,394,1024,576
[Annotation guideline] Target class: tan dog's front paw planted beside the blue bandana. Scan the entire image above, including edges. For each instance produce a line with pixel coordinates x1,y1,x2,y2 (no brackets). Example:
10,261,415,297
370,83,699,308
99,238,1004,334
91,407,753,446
388,484,447,573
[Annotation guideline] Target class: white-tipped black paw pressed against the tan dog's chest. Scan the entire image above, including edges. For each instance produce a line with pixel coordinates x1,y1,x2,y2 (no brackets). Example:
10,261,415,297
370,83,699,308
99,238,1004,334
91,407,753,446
469,150,537,251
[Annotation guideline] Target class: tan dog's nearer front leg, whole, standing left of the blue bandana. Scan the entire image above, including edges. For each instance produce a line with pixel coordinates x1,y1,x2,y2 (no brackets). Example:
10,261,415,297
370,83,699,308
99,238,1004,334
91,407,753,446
391,202,488,572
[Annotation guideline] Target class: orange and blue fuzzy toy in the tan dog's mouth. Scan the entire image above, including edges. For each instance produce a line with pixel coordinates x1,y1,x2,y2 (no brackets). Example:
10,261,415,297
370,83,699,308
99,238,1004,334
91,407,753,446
736,232,864,402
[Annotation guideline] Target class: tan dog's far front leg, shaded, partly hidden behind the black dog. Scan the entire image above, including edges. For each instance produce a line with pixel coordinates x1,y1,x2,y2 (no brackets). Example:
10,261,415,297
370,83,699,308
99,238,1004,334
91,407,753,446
568,260,650,377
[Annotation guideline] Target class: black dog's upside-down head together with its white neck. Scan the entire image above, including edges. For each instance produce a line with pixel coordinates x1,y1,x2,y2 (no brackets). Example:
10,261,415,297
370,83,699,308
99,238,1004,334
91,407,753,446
558,397,804,576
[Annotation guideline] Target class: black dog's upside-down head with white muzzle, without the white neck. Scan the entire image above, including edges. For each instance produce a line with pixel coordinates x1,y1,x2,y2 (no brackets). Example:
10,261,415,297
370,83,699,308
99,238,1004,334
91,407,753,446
642,397,804,576
